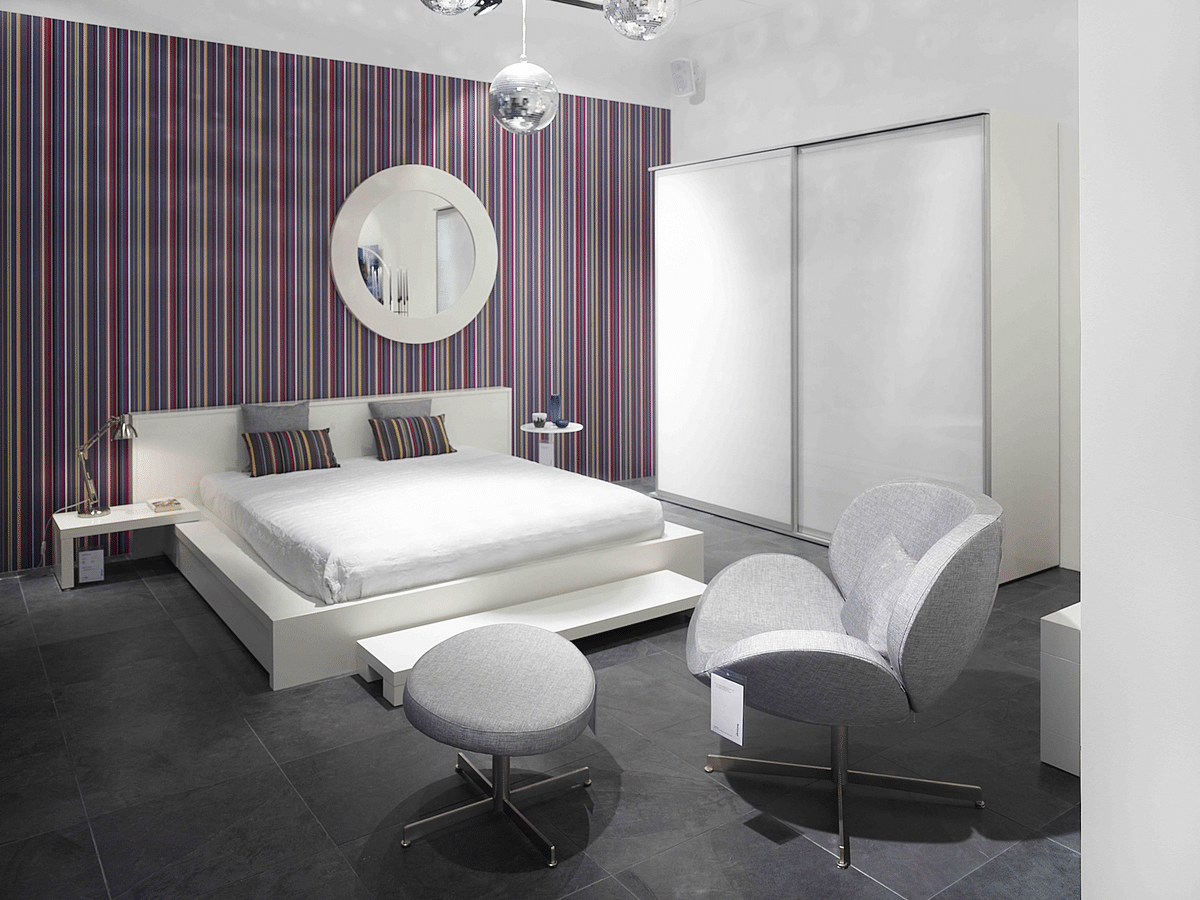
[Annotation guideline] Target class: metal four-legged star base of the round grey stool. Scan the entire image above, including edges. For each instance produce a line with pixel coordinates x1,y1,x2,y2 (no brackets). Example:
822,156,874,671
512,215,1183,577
400,754,592,866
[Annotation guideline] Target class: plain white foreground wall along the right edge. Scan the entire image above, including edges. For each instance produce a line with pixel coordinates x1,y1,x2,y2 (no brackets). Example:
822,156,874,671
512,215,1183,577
1079,0,1200,900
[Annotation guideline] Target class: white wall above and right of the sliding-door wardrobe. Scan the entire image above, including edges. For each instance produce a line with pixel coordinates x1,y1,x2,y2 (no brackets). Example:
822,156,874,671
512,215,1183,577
656,0,1079,569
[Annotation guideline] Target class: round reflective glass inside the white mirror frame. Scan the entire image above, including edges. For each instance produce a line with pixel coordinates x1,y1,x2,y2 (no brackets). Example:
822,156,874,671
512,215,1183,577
358,191,475,318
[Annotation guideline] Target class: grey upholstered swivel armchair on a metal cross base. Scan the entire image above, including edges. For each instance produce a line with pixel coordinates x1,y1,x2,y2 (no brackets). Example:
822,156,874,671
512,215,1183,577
688,480,1003,869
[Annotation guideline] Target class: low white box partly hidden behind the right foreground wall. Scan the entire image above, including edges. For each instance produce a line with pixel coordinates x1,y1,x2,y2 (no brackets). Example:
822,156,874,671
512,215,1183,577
1042,604,1081,775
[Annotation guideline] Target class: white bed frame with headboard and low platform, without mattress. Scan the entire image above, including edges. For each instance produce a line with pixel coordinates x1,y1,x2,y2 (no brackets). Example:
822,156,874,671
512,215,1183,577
131,388,704,690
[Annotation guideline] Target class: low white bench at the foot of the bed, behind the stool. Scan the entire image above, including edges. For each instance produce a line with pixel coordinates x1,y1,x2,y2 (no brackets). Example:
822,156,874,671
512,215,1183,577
359,570,704,706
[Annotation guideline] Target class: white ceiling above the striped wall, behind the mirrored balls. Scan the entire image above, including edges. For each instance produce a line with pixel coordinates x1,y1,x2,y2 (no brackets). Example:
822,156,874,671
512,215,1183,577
0,0,791,106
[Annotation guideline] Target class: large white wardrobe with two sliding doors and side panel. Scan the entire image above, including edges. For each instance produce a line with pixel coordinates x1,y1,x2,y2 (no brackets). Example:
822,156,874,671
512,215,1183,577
654,113,1058,581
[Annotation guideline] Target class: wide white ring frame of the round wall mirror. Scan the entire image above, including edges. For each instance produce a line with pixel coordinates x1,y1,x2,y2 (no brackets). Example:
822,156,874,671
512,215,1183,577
329,166,497,343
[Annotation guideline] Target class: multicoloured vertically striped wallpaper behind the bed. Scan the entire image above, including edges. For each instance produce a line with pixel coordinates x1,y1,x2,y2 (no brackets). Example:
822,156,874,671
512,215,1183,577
0,12,670,571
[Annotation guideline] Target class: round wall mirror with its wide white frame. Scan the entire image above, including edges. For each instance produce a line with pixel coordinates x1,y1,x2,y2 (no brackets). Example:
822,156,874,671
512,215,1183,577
330,166,497,343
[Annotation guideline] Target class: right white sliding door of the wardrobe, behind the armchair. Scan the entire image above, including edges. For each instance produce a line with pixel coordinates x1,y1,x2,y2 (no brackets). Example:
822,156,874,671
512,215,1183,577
798,118,986,535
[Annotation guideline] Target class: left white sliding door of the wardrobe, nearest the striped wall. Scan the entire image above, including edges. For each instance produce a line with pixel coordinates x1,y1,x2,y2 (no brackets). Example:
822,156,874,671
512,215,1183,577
655,149,794,529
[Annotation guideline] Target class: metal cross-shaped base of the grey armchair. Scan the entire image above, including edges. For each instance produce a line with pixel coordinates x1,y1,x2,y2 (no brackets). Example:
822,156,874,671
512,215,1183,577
704,726,986,869
